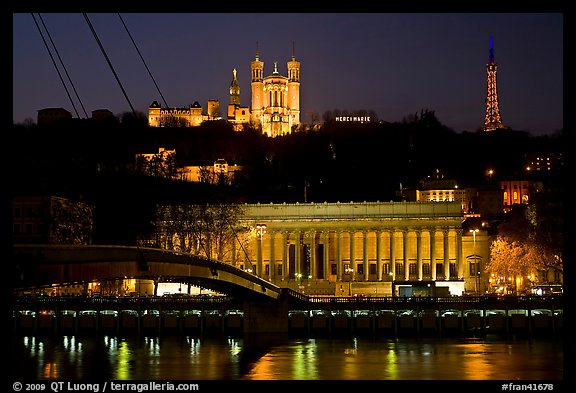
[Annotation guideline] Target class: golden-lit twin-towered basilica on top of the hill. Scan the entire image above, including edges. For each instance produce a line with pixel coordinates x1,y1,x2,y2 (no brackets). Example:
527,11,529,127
251,46,300,137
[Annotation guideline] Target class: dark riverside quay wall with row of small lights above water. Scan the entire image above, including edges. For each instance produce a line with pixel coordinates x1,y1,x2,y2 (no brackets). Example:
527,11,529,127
13,296,564,338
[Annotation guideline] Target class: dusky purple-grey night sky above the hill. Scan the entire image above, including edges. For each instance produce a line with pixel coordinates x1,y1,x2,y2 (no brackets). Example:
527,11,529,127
13,12,564,135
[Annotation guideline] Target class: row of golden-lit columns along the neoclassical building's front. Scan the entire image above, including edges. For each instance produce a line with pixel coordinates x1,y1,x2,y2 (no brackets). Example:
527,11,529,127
241,223,464,282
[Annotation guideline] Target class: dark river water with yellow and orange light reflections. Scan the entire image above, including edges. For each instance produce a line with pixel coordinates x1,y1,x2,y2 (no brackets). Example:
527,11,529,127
11,336,563,381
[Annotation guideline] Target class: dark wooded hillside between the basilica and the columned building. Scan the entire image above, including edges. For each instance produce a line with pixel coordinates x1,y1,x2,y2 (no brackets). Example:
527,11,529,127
10,111,565,243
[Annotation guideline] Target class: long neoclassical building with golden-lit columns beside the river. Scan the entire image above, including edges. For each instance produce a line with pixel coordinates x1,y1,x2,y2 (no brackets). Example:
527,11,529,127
231,202,489,296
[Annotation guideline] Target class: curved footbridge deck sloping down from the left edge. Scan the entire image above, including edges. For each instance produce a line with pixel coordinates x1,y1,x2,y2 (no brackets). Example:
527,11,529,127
12,244,298,300
